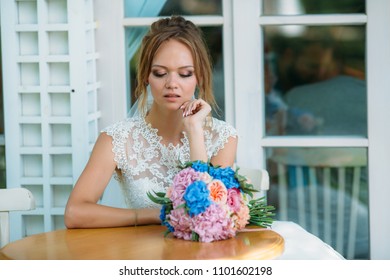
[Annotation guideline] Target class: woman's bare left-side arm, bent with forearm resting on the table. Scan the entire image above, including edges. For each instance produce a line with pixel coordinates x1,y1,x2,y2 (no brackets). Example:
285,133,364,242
65,133,160,228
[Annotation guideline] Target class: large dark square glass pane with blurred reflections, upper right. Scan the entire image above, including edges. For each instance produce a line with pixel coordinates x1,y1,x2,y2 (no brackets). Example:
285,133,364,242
264,26,367,136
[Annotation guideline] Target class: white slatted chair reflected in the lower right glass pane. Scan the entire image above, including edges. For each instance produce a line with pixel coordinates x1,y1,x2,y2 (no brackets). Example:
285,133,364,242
270,148,368,259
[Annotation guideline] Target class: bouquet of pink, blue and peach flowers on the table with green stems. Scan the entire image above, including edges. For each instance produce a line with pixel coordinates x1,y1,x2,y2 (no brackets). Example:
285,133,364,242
148,161,274,242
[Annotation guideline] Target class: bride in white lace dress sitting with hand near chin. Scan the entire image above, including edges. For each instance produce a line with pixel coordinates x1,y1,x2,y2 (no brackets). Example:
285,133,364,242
65,16,237,228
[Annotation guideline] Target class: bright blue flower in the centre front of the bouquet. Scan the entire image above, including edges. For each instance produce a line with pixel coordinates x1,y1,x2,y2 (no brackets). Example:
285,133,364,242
183,181,211,217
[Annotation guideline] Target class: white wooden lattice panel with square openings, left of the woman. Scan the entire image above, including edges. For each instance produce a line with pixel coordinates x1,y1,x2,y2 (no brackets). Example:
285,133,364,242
1,0,100,240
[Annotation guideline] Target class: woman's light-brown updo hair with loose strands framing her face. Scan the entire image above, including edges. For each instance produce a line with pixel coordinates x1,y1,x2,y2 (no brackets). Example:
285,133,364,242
135,16,217,115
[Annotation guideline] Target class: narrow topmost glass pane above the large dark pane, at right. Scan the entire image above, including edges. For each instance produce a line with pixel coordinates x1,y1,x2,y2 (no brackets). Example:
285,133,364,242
263,0,366,15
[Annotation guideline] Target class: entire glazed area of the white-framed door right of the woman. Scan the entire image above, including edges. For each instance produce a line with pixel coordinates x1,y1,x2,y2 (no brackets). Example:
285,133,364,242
260,0,370,259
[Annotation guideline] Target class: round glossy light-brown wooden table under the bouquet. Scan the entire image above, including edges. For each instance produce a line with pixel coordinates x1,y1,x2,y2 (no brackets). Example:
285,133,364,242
0,225,284,260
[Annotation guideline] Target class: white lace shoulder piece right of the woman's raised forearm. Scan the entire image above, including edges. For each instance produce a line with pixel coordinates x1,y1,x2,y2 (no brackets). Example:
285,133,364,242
209,118,238,156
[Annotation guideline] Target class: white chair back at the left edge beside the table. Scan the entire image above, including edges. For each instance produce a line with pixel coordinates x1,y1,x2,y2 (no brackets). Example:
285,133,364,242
0,188,35,248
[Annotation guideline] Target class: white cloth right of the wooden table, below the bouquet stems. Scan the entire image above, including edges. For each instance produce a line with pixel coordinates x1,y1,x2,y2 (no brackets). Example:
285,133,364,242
272,221,344,260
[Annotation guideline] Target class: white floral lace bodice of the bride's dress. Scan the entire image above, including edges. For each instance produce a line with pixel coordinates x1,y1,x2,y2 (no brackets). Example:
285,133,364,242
103,117,237,208
